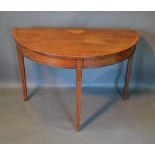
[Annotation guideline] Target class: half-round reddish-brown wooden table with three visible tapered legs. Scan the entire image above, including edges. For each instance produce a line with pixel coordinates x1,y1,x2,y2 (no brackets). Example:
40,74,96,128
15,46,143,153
13,28,139,131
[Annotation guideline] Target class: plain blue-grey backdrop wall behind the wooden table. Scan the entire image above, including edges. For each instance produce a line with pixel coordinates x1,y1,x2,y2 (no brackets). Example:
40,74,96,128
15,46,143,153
0,12,155,88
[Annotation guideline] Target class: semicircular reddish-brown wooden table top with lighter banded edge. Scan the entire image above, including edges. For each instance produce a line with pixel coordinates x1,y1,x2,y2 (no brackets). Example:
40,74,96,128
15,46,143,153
13,28,139,59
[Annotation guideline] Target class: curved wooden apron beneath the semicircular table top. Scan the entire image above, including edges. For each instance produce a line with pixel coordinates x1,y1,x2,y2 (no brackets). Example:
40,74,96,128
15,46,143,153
17,45,134,69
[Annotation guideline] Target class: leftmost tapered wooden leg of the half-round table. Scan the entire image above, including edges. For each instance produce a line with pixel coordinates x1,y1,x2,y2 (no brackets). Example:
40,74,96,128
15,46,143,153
18,51,28,101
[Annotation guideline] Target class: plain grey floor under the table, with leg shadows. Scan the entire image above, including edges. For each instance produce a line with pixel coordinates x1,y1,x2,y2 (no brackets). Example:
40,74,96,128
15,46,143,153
0,87,155,143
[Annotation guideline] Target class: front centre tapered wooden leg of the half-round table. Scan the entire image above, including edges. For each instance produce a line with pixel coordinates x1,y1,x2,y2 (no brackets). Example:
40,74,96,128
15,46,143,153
75,60,82,131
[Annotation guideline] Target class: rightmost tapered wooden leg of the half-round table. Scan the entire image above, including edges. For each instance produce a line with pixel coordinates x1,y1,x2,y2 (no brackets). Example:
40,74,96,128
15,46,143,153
123,53,134,100
